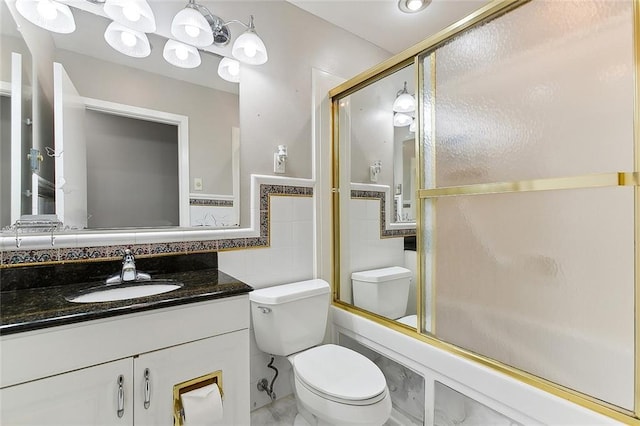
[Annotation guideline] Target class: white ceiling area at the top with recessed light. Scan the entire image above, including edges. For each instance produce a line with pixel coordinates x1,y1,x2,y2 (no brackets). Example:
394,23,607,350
287,0,489,54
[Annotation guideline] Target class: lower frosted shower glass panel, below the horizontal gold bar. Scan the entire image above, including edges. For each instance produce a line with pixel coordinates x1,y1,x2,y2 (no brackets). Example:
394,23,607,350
434,187,634,409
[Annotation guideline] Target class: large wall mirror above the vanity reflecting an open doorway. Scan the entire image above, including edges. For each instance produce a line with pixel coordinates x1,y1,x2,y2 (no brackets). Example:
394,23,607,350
0,0,240,230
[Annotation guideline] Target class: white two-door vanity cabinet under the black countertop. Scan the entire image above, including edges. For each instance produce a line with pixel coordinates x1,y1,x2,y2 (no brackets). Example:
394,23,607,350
0,295,250,426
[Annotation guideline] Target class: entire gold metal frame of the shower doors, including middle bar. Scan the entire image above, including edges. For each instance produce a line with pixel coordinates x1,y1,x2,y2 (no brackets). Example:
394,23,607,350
329,0,640,426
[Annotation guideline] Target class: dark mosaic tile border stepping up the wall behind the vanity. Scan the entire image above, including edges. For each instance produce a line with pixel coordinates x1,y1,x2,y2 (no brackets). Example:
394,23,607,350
0,184,313,268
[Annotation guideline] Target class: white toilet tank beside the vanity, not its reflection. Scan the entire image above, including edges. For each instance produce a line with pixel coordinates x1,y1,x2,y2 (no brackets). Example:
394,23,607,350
249,280,330,356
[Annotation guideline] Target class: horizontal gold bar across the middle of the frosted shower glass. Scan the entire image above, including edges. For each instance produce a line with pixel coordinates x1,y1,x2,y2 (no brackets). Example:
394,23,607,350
418,172,640,199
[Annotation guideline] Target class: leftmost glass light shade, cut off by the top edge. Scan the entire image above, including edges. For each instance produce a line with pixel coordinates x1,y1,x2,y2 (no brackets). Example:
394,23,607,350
16,0,76,34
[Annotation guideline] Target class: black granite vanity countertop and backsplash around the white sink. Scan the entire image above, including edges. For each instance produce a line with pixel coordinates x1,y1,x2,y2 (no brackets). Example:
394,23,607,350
0,253,252,335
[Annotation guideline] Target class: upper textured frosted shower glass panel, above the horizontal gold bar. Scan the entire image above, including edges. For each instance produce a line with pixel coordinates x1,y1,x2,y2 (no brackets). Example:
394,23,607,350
423,0,635,188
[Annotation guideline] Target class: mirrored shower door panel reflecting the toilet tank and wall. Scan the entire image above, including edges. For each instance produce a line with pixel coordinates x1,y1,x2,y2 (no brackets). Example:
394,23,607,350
336,64,417,327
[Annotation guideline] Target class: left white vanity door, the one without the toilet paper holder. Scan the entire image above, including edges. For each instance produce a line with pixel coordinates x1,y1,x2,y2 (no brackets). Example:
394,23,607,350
0,358,133,426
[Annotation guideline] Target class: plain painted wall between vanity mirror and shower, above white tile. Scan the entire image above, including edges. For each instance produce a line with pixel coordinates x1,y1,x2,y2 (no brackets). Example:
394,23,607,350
236,1,391,226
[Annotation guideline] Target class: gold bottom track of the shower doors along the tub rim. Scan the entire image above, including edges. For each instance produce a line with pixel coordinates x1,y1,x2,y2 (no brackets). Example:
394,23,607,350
335,302,640,426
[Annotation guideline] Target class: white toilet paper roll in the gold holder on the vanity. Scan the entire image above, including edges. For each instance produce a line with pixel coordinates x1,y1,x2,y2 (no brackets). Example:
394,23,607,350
180,383,224,426
